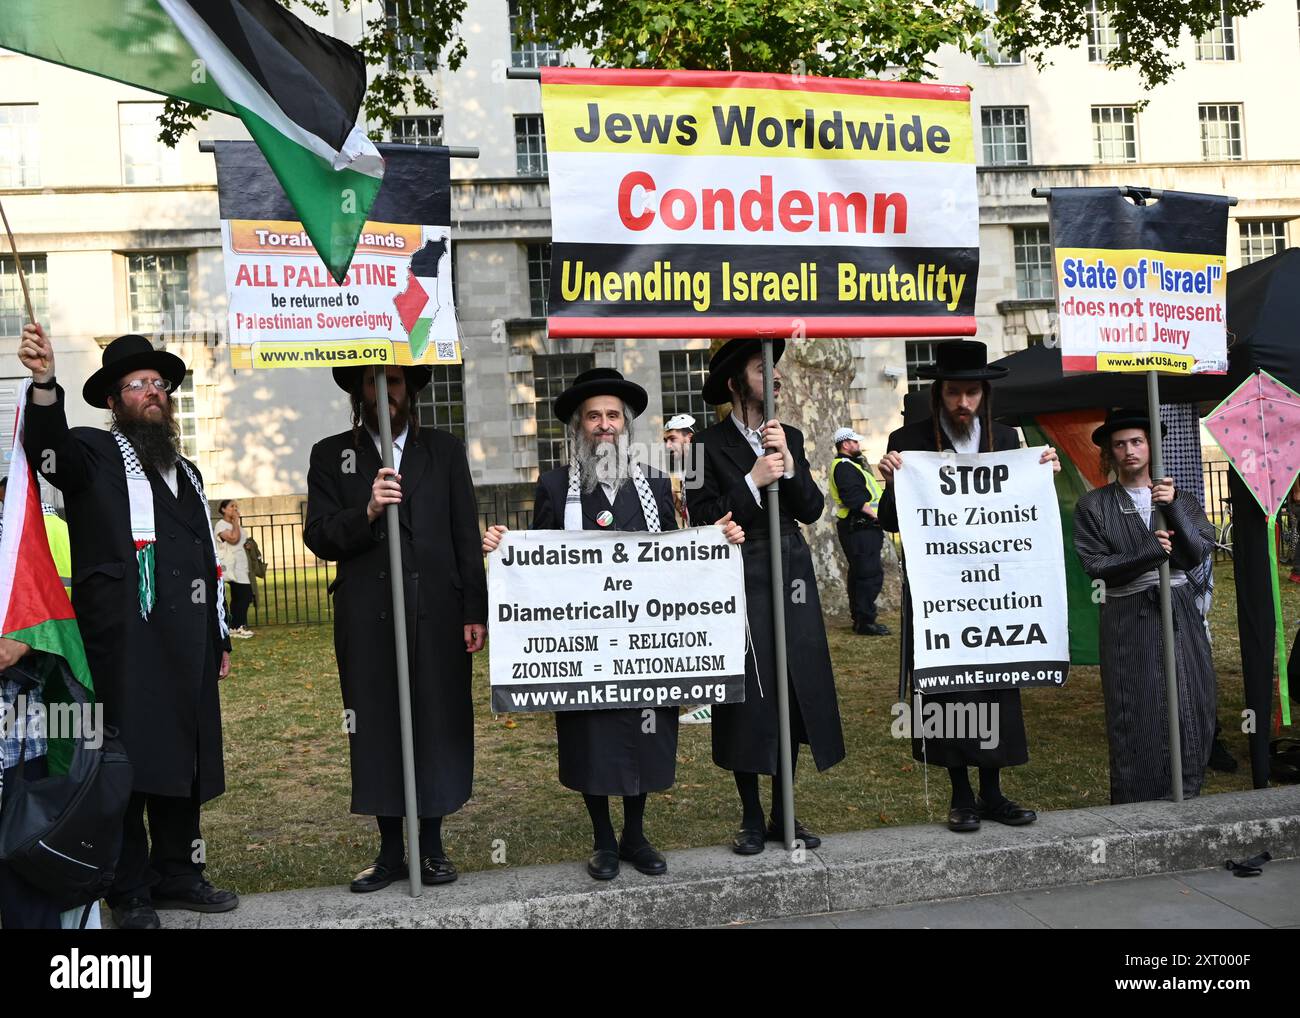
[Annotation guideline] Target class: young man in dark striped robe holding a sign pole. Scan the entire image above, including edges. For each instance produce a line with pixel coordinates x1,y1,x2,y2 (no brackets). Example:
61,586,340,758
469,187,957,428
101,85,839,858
1074,410,1217,803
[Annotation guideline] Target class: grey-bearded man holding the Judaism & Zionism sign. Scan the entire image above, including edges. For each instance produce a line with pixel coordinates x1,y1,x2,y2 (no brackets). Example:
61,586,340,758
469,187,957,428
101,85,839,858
482,368,744,880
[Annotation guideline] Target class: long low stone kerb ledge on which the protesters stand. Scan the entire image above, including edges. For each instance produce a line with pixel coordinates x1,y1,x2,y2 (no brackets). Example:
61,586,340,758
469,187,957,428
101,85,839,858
139,785,1300,930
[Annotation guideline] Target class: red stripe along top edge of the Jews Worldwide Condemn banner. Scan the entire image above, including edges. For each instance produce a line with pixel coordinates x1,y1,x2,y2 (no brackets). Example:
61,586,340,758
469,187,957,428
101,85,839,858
542,68,971,103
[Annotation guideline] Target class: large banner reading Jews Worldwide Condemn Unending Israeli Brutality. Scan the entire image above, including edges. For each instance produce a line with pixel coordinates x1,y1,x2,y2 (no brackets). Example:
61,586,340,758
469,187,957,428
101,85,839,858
542,68,979,337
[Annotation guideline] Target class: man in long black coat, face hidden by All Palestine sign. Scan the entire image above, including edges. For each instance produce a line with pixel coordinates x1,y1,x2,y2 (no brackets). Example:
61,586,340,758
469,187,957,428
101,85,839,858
303,365,488,893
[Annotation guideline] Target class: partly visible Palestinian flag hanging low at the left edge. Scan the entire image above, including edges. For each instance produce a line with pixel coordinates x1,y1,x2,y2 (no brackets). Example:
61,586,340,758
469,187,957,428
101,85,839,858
0,380,94,774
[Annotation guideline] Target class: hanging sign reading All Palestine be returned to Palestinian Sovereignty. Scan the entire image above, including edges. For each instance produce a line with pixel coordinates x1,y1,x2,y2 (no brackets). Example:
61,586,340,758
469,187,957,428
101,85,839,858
216,142,460,368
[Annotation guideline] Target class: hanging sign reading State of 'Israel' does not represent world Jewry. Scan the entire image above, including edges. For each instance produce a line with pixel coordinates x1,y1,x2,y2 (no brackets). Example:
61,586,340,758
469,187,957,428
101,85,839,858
1050,187,1229,374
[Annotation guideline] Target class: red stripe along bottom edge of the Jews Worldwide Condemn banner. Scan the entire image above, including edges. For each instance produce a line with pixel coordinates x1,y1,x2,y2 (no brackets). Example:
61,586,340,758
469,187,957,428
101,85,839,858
546,315,975,339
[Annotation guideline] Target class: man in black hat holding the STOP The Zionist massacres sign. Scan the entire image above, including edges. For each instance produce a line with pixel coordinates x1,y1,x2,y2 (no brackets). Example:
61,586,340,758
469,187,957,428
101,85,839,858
879,339,1061,831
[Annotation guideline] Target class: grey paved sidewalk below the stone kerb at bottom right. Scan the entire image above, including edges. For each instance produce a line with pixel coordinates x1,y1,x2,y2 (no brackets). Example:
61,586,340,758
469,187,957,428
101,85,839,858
736,859,1300,930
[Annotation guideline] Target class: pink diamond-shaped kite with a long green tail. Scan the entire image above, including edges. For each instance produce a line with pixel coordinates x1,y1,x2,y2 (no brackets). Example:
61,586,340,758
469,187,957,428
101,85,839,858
1205,371,1300,724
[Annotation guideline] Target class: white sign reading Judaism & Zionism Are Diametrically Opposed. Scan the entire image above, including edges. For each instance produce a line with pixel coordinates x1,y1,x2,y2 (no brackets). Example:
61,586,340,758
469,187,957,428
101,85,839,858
488,527,745,711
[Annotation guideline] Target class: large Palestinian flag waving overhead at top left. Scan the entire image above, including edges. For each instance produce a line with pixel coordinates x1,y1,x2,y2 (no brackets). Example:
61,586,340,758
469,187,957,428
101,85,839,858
0,0,384,282
